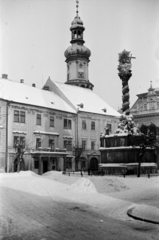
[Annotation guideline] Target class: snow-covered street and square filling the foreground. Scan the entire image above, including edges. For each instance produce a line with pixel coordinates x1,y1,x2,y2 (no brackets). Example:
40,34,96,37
0,171,159,240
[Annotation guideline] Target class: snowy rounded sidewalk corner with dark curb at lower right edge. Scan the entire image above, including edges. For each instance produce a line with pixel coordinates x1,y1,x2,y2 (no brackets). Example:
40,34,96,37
128,205,159,224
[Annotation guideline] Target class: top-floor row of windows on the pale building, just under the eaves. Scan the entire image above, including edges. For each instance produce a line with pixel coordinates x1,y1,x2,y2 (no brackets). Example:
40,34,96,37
14,110,95,130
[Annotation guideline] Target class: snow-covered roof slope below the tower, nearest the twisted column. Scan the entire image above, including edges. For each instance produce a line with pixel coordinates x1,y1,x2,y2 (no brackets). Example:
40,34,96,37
49,80,120,117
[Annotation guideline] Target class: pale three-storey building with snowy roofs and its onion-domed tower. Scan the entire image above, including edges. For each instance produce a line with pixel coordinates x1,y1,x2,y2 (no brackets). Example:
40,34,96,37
0,6,120,174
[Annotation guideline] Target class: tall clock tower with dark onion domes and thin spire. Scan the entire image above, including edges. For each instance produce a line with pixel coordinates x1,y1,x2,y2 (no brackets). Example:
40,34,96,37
64,0,94,90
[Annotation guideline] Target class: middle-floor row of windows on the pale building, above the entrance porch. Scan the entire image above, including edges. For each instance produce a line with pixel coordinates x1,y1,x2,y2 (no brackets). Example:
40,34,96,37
13,136,96,151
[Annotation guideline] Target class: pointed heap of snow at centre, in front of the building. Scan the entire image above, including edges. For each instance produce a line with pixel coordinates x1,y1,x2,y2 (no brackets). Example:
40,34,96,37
67,178,97,193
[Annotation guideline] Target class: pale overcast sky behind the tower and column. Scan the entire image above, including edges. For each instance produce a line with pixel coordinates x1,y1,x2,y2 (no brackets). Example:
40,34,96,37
0,0,159,110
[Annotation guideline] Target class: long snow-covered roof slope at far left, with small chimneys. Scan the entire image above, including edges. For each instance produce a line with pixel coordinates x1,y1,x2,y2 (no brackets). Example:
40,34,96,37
0,78,76,113
